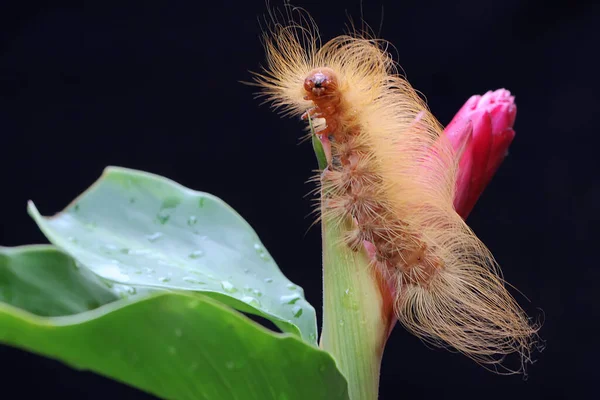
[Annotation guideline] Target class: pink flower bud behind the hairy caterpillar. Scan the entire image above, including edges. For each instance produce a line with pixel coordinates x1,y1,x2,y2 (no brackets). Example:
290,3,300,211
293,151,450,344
444,89,517,218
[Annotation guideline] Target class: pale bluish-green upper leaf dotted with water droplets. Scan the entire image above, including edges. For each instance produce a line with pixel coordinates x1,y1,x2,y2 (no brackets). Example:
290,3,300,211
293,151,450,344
28,167,317,344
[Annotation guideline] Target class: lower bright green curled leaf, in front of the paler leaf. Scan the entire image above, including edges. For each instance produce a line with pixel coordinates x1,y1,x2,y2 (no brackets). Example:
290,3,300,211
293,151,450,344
0,246,348,400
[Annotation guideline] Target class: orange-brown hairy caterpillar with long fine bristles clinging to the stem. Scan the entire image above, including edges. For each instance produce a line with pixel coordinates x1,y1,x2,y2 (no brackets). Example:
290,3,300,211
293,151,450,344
255,7,537,372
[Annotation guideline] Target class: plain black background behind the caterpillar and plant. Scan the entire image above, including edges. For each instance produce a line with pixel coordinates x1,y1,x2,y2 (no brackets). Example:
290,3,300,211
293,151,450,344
0,0,600,400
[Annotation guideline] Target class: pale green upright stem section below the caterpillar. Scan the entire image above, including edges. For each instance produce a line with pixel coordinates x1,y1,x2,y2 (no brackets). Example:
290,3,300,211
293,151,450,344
321,220,388,400
